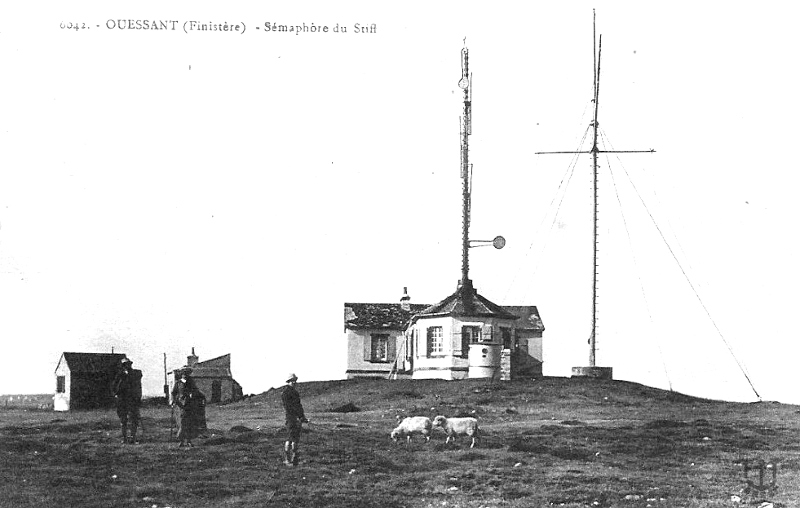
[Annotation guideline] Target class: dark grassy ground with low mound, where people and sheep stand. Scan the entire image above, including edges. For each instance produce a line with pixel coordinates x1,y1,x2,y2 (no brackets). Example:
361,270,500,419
0,378,800,508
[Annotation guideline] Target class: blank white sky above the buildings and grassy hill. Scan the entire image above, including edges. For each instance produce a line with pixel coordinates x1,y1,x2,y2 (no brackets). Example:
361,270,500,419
0,1,800,404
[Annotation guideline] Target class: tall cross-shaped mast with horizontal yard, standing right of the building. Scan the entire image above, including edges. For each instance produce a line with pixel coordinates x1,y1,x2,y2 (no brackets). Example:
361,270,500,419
536,10,655,377
